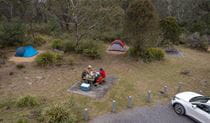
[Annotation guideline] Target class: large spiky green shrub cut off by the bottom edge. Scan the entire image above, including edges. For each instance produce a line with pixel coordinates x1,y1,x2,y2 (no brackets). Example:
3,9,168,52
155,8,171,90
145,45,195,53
45,105,77,123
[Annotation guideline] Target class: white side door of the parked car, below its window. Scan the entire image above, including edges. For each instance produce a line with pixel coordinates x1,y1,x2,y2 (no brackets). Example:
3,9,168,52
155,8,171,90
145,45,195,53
190,104,210,123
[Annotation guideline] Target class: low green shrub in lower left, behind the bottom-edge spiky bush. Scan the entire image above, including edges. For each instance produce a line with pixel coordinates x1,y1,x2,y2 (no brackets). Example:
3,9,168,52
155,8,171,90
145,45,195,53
16,96,39,107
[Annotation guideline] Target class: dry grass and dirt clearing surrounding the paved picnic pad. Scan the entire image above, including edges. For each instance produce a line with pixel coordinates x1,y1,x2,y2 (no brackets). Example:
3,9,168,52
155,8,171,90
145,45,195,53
0,47,210,120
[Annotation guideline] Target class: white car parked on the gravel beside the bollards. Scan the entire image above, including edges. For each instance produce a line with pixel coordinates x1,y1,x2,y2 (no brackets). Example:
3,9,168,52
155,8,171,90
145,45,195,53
171,92,210,123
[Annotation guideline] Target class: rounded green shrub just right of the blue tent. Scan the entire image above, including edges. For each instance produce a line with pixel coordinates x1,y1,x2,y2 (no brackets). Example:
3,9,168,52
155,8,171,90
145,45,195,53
35,52,63,67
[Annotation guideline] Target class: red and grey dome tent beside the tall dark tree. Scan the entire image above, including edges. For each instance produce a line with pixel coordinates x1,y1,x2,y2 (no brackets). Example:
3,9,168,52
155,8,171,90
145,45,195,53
109,40,126,52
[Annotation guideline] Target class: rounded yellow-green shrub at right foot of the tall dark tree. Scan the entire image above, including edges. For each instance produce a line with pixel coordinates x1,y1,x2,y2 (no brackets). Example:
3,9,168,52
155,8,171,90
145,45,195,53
142,48,165,62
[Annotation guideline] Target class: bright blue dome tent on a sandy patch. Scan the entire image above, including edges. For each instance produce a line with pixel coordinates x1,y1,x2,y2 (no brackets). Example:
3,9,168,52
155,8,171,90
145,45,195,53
15,46,38,57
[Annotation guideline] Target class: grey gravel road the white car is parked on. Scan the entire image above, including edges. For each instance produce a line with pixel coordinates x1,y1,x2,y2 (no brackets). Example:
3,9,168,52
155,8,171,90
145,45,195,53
90,105,195,123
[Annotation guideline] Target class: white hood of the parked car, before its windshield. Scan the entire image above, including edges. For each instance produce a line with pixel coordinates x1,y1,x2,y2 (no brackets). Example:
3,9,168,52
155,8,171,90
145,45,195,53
176,92,202,102
